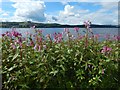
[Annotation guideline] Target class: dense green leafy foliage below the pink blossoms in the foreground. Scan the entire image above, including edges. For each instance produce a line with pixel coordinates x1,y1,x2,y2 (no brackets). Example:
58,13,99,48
2,27,120,90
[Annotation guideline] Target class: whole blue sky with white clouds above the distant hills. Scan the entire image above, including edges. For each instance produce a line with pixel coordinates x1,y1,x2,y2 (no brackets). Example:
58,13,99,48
0,0,118,25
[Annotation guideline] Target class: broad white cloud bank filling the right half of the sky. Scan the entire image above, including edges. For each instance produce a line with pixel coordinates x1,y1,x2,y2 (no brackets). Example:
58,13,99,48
57,2,118,24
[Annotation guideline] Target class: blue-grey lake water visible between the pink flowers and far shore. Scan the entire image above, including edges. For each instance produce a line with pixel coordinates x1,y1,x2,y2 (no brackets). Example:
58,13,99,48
0,28,118,40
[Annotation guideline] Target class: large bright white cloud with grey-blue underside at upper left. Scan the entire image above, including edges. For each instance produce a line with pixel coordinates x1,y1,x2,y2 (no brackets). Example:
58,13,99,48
11,0,46,22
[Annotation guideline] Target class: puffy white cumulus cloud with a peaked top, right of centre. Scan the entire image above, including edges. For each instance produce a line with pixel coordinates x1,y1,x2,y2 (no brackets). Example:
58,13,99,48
57,5,89,24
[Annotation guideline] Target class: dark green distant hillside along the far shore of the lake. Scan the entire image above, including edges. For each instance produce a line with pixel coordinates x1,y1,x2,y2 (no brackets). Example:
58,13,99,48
0,21,118,28
